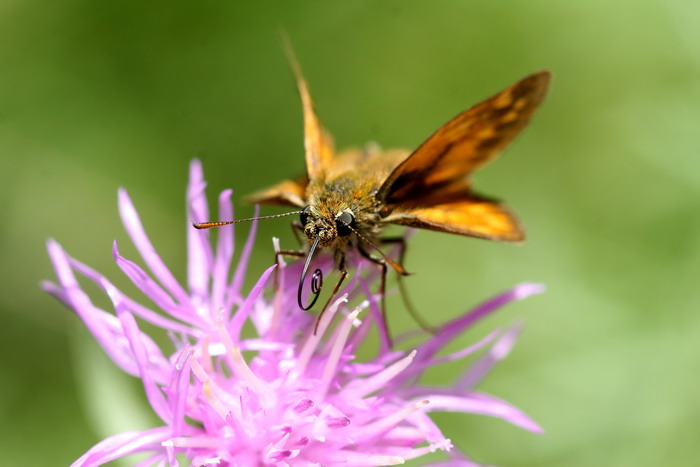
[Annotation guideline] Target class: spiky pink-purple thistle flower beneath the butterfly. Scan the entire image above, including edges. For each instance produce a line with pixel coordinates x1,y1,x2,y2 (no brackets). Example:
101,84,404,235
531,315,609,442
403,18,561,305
42,161,542,466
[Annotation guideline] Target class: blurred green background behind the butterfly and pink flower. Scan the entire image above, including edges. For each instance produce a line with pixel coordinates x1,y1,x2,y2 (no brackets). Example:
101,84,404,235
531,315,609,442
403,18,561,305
0,0,700,466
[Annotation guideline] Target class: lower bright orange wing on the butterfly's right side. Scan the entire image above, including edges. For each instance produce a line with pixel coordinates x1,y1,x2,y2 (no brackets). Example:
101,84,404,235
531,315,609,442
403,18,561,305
384,195,525,243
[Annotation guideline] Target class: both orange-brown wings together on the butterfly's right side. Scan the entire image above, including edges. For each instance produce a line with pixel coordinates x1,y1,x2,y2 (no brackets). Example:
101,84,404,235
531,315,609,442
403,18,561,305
377,71,550,242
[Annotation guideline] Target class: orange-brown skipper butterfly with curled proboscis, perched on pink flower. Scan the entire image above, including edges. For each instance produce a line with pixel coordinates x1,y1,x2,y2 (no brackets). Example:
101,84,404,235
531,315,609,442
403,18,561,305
194,53,551,323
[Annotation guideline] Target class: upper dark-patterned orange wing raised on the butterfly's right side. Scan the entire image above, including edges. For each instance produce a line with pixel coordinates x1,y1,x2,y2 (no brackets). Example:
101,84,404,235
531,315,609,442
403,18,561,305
378,71,550,204
